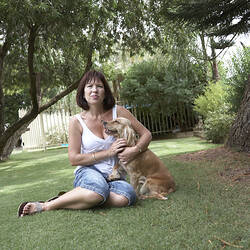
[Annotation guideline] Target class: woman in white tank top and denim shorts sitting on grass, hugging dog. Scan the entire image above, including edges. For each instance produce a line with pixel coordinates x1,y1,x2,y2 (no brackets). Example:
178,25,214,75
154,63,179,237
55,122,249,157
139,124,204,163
18,71,151,216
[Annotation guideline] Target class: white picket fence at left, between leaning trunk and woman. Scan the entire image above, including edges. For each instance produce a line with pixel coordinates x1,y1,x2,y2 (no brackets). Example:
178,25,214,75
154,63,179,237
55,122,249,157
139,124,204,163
19,110,70,149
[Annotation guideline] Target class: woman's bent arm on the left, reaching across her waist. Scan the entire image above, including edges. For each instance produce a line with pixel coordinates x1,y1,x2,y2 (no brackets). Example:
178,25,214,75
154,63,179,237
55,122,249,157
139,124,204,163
68,117,126,166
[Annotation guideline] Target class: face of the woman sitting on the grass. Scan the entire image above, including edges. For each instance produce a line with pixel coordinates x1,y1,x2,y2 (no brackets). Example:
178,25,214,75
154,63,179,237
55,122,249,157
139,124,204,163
84,79,105,105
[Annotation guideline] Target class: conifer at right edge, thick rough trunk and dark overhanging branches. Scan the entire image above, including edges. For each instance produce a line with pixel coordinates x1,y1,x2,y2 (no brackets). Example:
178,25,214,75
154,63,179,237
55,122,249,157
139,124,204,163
164,0,250,152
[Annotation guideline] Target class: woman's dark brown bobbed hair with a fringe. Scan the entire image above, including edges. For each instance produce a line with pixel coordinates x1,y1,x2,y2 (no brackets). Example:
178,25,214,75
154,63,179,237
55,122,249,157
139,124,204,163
76,70,115,110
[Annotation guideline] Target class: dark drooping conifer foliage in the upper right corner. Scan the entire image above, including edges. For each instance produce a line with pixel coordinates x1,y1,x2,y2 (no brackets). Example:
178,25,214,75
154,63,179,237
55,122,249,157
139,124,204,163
163,0,250,37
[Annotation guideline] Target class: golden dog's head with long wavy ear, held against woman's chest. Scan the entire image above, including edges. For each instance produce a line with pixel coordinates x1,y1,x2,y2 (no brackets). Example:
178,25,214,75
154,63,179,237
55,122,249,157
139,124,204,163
103,117,136,146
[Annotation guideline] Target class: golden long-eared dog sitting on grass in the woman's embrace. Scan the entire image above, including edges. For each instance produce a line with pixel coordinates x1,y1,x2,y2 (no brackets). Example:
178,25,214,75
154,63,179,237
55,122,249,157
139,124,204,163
103,117,175,200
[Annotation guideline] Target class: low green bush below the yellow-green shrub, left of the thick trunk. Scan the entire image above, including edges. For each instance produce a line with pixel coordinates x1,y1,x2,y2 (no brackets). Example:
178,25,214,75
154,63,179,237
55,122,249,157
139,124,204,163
204,110,235,143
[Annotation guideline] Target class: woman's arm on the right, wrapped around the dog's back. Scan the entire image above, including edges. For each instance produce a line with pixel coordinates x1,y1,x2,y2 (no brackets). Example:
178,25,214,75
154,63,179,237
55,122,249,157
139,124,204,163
117,106,152,164
